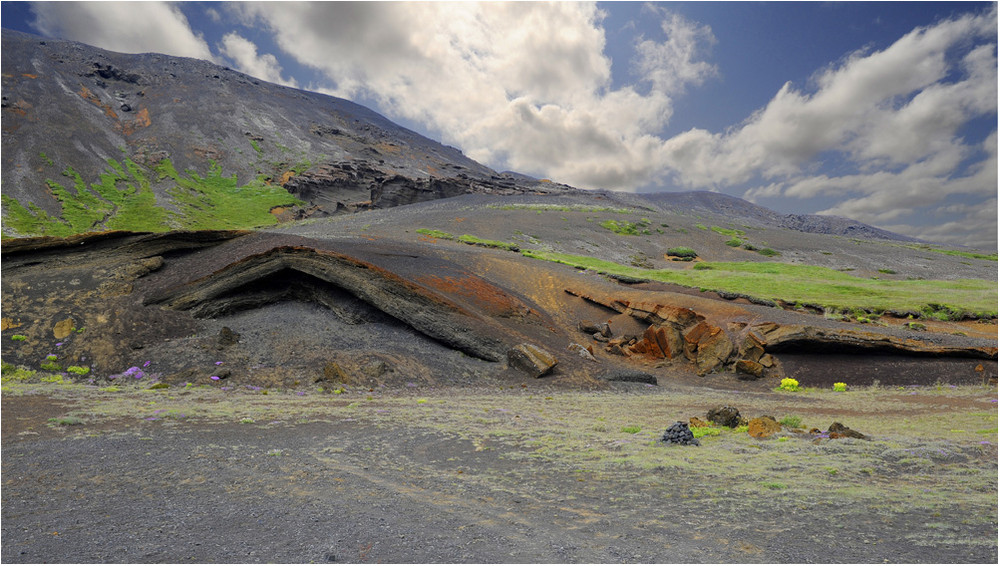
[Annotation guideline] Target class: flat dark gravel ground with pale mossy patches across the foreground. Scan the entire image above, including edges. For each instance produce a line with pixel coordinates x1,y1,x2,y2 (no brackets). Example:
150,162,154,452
2,388,997,563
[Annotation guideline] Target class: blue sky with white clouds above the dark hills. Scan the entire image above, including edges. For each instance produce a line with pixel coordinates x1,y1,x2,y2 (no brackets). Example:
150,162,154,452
2,2,998,249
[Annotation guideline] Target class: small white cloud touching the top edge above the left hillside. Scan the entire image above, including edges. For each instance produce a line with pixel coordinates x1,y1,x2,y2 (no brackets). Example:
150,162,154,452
32,2,213,61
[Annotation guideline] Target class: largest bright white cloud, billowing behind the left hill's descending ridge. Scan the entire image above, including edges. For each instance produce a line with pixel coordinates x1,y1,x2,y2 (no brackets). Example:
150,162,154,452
239,2,715,189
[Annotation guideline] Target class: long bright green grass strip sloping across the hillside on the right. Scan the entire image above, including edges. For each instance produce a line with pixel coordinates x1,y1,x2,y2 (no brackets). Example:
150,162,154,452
522,250,997,318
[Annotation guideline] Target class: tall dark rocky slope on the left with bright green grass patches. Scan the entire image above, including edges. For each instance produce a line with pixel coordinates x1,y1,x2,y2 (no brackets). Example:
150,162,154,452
2,30,565,236
